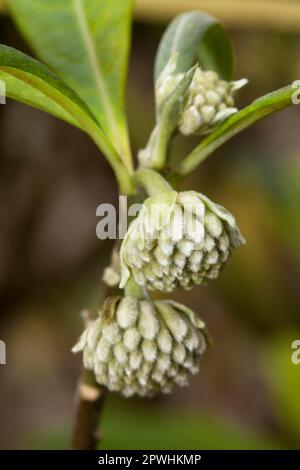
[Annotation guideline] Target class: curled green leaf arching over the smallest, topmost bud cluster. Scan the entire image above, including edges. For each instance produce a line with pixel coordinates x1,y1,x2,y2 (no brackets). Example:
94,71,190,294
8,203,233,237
155,12,233,80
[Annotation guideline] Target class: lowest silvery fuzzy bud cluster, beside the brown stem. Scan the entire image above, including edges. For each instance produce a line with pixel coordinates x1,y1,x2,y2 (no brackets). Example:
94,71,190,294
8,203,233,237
73,296,207,396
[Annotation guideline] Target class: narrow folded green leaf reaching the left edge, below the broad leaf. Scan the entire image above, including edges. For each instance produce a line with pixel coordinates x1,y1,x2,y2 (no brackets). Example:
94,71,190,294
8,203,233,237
0,44,134,195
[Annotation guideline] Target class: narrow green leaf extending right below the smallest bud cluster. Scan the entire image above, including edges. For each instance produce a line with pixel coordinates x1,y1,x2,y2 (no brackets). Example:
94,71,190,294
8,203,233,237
172,86,296,180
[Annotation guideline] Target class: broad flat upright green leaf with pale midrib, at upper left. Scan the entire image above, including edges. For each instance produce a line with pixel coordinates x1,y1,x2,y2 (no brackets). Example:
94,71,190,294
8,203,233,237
7,0,132,165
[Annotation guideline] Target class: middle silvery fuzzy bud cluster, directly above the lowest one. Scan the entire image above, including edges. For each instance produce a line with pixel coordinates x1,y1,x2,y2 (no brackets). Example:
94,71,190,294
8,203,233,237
120,191,245,292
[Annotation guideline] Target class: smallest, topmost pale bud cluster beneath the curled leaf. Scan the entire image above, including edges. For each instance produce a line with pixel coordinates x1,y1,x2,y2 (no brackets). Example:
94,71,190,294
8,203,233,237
178,67,248,135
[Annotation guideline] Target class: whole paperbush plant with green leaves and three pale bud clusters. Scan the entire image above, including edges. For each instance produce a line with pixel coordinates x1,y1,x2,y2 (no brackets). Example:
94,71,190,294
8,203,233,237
0,0,294,447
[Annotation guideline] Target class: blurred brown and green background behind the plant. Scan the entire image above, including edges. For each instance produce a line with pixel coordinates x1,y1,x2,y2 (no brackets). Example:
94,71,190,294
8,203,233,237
0,0,300,449
